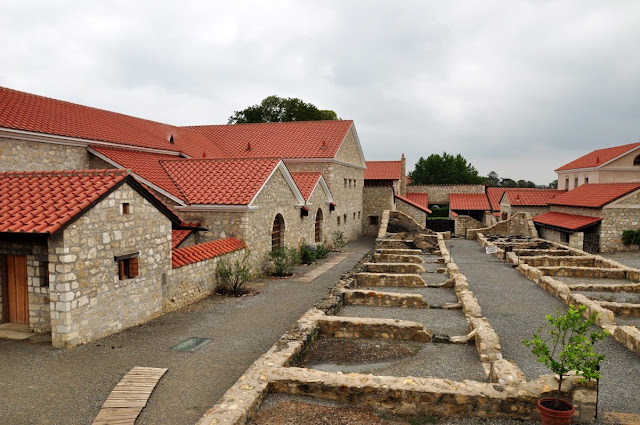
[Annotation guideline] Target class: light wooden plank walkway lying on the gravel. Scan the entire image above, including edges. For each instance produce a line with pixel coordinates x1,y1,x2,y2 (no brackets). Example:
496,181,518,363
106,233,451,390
93,366,167,425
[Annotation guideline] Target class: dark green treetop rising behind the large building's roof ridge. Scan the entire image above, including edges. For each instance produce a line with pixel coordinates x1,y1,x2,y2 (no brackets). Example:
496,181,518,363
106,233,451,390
228,96,339,124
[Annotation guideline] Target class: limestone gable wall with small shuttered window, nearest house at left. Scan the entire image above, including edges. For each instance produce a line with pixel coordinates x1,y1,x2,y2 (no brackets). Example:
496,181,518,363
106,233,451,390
49,184,171,348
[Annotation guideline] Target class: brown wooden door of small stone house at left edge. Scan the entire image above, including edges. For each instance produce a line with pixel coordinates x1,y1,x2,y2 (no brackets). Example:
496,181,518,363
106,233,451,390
3,255,29,324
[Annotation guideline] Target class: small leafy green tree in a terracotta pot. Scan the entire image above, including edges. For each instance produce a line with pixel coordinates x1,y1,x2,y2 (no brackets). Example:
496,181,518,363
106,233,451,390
522,305,609,424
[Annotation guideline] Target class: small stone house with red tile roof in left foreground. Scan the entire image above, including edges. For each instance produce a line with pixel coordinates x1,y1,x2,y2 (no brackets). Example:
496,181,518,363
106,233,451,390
0,170,212,347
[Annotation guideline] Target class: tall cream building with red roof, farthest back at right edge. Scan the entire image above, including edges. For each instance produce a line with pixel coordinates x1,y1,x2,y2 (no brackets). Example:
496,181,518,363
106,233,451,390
555,143,640,190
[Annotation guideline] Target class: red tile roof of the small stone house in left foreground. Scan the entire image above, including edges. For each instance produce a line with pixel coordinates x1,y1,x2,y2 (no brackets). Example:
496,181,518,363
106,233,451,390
0,170,128,234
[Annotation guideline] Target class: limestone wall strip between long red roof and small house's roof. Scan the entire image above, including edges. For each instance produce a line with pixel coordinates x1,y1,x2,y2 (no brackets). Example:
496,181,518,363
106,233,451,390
0,138,94,171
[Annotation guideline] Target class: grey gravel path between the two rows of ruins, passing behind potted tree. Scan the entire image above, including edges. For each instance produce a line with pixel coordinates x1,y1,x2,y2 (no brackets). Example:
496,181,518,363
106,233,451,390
447,239,640,414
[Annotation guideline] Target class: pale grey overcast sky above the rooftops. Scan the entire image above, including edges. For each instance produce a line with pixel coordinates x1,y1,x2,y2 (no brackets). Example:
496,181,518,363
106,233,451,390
0,0,640,184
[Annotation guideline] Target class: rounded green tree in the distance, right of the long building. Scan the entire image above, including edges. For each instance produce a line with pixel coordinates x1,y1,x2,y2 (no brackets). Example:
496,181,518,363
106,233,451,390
409,152,485,184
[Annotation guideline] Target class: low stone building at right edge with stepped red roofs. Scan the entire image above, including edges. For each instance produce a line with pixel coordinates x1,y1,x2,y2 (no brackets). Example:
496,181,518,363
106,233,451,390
533,183,640,253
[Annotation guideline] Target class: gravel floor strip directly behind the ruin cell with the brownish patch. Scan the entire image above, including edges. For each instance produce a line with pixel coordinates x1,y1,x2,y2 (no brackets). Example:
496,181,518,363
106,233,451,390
337,305,471,336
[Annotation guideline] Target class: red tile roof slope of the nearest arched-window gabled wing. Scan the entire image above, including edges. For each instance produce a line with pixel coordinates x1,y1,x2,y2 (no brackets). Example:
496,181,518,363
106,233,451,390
160,158,280,205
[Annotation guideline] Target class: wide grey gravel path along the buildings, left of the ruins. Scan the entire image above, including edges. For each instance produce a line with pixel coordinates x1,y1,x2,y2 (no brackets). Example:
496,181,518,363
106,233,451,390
0,238,374,425
